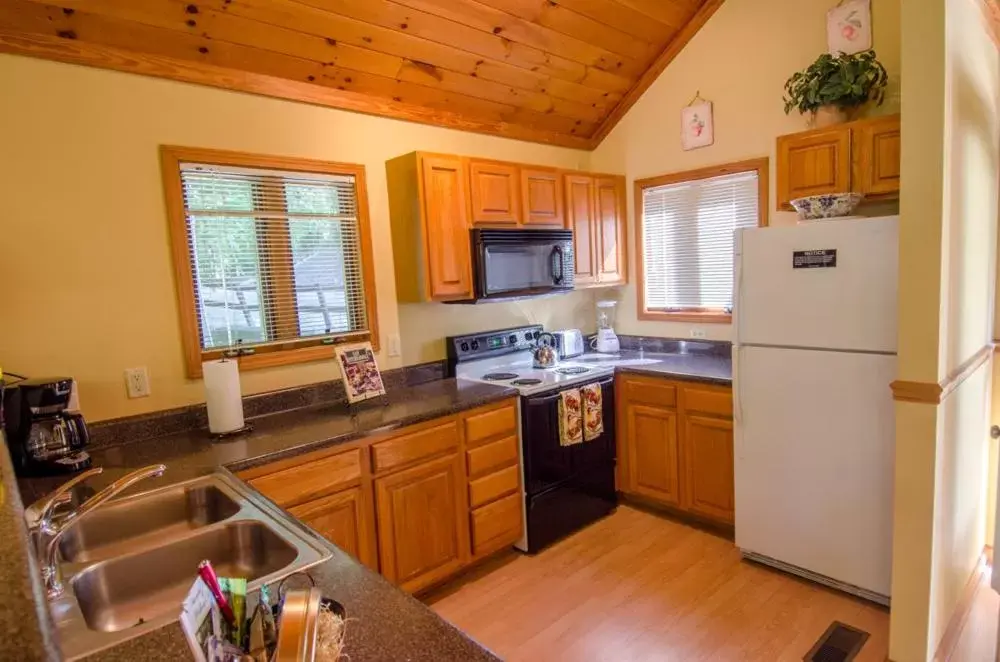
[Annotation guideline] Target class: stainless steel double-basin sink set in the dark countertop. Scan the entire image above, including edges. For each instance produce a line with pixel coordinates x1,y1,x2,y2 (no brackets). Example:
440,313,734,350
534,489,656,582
49,473,330,659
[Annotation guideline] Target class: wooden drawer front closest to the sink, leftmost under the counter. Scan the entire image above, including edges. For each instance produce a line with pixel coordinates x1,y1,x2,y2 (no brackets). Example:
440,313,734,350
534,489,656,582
250,449,361,507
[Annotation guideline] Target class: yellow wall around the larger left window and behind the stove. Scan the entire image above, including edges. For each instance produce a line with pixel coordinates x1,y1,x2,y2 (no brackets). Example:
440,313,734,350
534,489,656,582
0,55,593,420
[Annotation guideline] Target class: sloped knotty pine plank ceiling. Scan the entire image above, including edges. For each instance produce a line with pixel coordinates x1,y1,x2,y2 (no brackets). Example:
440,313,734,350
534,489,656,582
0,0,722,149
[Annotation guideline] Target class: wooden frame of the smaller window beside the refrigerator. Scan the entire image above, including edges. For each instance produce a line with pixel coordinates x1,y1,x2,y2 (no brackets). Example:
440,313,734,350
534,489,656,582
634,157,770,324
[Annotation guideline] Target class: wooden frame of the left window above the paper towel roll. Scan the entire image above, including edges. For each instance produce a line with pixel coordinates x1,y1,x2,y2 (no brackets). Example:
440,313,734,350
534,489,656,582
160,145,379,379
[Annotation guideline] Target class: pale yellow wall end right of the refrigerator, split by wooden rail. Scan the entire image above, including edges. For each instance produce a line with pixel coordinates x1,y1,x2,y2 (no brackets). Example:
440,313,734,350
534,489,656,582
889,0,1000,662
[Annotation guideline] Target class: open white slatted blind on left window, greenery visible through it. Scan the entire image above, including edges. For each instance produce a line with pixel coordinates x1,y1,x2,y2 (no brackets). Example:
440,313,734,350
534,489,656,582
181,163,368,350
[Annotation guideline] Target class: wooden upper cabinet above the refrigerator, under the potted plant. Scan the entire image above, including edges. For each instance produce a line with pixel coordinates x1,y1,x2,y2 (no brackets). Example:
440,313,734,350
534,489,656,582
776,115,900,210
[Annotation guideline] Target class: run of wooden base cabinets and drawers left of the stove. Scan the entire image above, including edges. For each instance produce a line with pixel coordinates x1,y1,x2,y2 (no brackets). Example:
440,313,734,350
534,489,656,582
239,399,523,593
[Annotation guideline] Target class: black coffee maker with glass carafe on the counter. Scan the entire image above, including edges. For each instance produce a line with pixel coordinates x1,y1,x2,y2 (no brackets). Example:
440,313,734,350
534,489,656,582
2,377,90,476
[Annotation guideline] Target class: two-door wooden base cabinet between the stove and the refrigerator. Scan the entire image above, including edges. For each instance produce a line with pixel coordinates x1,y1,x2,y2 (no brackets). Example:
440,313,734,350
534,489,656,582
616,374,734,525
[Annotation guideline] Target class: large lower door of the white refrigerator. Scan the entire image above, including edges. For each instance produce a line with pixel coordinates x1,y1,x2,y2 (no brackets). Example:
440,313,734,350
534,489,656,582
733,346,896,596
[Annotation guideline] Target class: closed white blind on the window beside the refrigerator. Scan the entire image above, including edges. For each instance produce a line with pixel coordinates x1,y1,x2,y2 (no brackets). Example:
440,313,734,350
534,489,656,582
642,171,759,312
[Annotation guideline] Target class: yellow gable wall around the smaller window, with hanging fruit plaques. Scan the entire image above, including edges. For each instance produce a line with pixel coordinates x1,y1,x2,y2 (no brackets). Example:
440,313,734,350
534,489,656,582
590,0,900,340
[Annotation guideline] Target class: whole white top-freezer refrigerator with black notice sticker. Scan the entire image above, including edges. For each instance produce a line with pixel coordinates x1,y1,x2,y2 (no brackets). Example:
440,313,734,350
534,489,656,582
733,217,899,604
